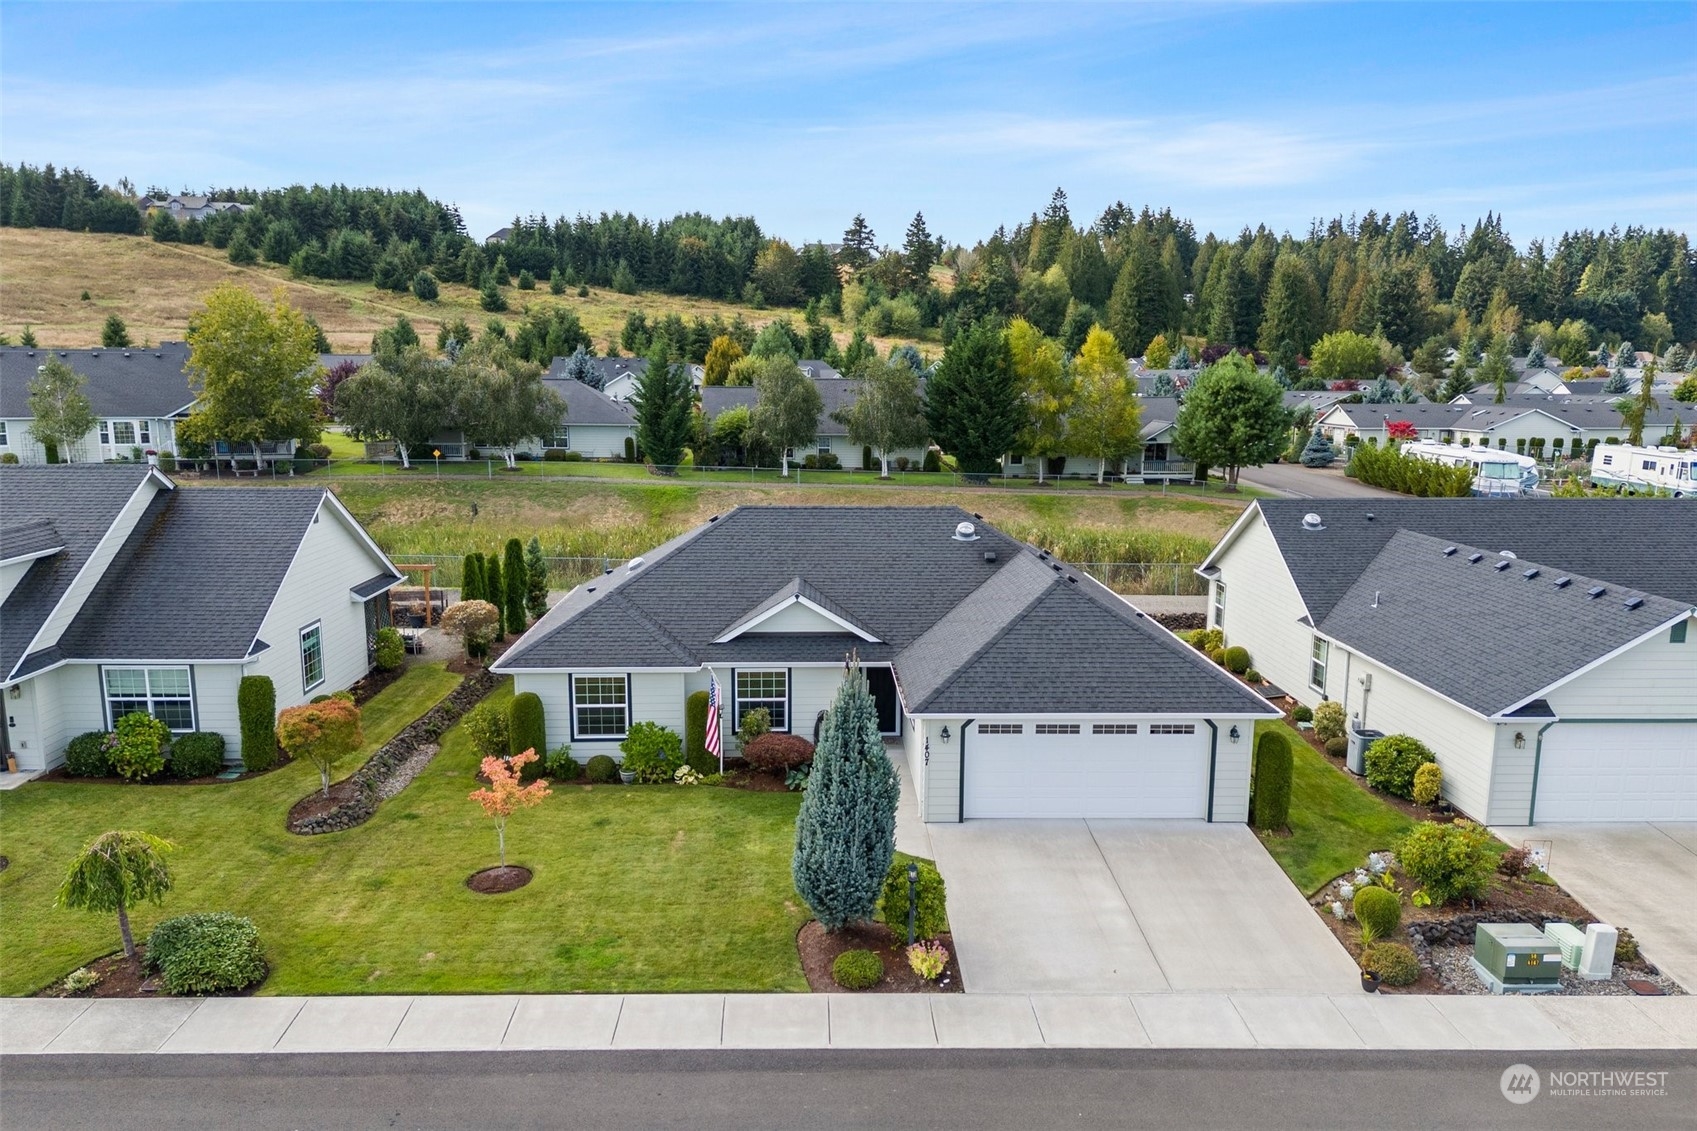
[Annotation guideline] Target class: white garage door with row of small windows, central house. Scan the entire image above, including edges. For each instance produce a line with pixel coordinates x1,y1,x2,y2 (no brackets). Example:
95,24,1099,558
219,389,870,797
964,720,1208,817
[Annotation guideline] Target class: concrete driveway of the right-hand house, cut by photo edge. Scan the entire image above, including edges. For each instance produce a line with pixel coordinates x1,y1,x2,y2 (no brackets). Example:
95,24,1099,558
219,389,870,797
1513,822,1697,993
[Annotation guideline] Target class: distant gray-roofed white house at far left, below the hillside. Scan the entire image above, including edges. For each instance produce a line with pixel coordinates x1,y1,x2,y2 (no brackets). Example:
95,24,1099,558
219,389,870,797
0,341,195,464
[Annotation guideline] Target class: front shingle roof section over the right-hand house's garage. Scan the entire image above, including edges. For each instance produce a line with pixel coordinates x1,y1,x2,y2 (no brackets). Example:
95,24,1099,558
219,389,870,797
1320,530,1690,715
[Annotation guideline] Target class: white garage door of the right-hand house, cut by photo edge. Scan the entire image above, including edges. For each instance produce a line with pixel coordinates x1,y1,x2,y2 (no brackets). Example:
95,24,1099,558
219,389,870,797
1540,723,1697,822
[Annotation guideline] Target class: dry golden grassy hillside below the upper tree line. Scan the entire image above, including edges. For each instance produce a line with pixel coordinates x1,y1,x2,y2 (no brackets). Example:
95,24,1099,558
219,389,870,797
0,228,942,353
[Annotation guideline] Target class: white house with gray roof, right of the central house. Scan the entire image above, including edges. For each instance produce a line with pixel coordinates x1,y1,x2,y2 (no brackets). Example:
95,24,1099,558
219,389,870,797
1198,499,1697,825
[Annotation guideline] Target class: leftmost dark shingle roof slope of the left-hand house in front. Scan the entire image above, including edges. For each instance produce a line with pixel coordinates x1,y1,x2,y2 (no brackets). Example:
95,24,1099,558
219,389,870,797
0,464,151,678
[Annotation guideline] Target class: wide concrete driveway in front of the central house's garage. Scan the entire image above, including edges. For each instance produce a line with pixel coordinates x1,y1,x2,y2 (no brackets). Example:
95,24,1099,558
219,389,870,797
927,820,1359,993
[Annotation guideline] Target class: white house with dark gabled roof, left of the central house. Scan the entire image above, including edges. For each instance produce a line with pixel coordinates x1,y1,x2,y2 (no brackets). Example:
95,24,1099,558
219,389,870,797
0,465,400,771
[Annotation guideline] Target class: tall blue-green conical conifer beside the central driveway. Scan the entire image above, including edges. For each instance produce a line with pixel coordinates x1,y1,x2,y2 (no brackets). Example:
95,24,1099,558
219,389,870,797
791,657,901,931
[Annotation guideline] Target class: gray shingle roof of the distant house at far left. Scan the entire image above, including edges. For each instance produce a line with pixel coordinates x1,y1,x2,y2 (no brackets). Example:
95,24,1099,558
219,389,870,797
0,341,195,419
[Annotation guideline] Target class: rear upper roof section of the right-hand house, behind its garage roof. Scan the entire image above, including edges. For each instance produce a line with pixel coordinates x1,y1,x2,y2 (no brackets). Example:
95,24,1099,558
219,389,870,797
1254,499,1697,620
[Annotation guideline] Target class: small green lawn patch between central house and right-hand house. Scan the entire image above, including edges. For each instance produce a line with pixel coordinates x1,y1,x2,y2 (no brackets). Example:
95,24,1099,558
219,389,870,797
1259,722,1415,895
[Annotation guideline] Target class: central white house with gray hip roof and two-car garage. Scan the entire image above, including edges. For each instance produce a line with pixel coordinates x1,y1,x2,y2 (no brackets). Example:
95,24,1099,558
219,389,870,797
494,506,1274,822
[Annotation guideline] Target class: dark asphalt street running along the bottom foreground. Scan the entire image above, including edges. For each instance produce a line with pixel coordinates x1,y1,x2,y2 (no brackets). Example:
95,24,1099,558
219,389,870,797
0,1049,1697,1131
